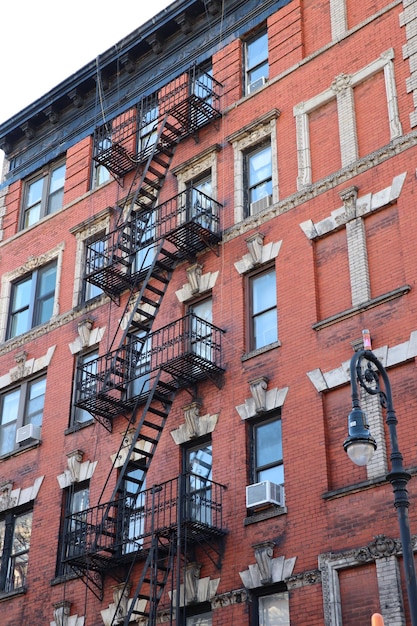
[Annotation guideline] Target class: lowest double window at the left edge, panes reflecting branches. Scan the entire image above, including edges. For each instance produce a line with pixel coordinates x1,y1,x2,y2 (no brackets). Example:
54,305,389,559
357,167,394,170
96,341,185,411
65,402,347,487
0,510,32,593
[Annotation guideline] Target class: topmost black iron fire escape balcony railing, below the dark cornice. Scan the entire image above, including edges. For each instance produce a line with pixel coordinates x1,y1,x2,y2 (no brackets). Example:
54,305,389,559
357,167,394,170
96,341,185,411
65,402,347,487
94,66,222,177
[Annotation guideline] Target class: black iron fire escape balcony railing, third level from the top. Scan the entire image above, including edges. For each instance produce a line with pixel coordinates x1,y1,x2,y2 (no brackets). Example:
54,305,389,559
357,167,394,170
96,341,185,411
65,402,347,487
76,313,224,419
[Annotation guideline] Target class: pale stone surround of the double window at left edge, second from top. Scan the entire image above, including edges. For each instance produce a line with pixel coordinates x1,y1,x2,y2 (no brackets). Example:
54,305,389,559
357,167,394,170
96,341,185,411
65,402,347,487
0,242,65,343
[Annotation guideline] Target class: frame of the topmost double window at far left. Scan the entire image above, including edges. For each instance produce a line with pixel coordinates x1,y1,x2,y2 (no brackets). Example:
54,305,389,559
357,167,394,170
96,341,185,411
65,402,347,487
19,158,66,230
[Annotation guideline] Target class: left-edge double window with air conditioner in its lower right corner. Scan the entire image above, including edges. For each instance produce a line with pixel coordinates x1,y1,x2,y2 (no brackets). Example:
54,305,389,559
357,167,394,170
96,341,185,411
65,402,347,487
0,376,46,456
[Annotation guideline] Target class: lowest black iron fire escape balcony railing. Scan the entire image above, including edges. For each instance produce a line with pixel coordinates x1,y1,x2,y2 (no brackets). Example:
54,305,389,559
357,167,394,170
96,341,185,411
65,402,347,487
64,473,226,572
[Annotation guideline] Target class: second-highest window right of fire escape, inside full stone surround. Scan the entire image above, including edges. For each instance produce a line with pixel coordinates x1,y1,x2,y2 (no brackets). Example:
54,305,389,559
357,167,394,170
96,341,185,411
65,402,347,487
245,142,272,215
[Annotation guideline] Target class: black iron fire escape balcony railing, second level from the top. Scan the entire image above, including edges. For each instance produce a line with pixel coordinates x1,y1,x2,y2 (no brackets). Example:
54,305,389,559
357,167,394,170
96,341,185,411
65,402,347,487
85,187,222,294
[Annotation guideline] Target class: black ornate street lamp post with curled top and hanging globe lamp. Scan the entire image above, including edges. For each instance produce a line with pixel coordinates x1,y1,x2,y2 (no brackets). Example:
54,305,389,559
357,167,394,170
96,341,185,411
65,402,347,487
343,350,417,626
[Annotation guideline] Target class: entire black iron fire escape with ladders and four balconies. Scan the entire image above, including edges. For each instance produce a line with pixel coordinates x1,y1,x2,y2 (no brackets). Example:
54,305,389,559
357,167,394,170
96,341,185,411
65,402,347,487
64,68,226,626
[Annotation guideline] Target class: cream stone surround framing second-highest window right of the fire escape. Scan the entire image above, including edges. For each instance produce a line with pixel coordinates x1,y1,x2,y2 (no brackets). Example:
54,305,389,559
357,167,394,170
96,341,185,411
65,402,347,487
227,109,280,223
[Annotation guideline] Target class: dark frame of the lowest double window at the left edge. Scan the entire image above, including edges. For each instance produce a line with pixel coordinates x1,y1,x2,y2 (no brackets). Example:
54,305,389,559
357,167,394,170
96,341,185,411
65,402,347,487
0,506,33,597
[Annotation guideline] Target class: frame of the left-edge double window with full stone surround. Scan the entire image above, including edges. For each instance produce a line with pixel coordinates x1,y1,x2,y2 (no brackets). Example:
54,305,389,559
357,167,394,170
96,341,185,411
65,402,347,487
6,259,58,341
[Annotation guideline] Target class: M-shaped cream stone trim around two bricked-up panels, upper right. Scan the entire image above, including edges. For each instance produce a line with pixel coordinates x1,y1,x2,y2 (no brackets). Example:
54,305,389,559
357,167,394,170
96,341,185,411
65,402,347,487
293,48,402,190
